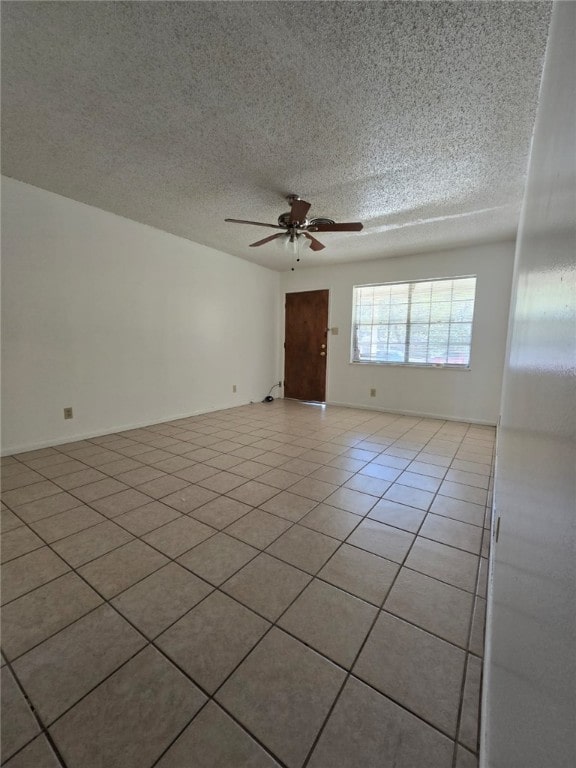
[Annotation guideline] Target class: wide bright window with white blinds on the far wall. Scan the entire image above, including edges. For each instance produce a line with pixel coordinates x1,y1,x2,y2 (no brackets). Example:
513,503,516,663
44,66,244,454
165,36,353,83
351,277,476,368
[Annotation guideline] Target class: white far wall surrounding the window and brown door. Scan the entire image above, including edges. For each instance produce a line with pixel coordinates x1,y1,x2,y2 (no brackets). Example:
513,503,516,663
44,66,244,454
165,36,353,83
279,242,514,424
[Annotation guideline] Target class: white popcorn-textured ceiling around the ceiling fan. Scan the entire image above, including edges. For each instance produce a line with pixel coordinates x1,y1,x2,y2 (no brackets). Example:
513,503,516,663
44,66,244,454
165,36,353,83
2,2,550,269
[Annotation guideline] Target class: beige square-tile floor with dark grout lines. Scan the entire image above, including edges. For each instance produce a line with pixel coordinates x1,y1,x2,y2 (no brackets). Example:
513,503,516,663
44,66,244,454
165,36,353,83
2,400,495,768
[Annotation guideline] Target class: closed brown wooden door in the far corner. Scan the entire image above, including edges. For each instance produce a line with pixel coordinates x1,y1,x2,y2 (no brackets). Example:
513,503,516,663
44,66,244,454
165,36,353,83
284,291,328,403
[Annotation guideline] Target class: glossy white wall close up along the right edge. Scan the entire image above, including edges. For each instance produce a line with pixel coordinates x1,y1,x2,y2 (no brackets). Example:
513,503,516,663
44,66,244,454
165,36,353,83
481,2,576,768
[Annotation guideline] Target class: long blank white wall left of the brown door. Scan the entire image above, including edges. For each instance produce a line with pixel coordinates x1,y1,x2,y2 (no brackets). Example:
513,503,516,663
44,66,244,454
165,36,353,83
2,179,278,453
